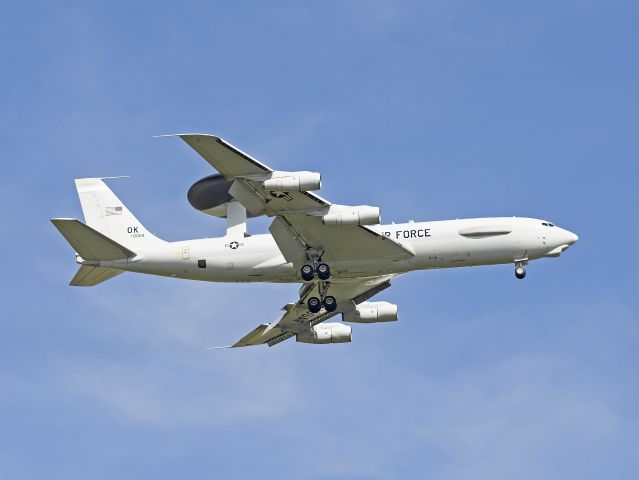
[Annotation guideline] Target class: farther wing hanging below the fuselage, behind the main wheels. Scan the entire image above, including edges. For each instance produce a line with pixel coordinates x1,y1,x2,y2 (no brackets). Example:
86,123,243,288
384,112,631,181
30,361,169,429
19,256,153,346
228,275,393,348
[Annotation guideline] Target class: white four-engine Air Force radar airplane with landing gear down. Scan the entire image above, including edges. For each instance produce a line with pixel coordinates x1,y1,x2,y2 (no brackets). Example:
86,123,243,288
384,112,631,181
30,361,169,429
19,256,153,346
51,134,578,348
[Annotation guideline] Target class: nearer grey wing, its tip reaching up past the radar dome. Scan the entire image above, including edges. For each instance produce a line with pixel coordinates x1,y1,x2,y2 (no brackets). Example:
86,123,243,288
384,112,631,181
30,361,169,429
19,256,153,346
179,134,414,262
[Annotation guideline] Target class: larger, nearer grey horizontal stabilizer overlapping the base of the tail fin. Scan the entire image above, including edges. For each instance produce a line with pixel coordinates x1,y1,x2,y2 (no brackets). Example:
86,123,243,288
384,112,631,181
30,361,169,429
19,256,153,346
51,218,135,261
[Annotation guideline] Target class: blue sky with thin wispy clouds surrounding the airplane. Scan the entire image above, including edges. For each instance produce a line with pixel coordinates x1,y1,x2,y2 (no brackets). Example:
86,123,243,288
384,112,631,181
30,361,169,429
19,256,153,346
0,0,639,480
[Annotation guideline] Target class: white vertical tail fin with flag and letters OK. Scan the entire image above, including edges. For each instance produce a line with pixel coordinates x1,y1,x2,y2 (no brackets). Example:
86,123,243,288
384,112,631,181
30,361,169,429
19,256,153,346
75,178,163,249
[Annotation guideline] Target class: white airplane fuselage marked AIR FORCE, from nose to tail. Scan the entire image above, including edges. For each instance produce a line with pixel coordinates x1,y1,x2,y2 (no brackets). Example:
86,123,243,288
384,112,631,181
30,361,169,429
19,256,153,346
95,217,577,283
